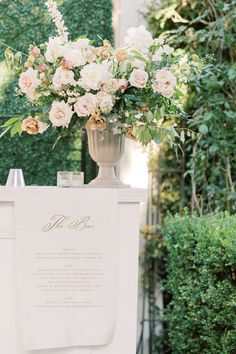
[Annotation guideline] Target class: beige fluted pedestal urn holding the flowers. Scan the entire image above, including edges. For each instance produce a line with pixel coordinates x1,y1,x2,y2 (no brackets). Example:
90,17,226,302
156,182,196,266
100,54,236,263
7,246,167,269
86,127,129,188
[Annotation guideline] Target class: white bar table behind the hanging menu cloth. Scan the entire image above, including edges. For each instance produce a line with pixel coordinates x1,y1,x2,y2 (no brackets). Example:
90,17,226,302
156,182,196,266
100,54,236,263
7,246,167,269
0,187,146,354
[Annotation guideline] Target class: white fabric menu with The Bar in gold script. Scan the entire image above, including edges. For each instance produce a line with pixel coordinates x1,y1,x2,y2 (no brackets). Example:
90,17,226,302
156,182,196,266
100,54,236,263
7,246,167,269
15,189,118,351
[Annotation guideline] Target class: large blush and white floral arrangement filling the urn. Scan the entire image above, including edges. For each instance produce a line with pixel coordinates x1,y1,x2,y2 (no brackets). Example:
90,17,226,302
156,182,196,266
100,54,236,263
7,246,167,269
2,0,201,145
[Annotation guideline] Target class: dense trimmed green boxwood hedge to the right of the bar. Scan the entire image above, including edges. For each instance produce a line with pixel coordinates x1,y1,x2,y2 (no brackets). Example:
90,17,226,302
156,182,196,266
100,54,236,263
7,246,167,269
164,214,236,354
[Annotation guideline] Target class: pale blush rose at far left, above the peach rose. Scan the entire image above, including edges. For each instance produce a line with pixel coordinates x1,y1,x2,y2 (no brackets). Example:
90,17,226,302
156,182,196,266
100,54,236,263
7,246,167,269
19,68,41,99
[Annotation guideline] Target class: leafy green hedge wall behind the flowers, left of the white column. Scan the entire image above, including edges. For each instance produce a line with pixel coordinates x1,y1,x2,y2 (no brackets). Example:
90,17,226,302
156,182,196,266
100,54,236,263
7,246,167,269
0,0,112,185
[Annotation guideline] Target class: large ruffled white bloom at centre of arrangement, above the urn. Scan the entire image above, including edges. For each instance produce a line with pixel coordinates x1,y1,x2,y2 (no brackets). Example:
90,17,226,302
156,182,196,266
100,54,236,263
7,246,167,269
79,62,112,91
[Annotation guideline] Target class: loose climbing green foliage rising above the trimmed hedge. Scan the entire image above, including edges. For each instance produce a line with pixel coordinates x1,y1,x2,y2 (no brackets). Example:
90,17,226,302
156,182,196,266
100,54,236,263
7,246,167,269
146,0,236,213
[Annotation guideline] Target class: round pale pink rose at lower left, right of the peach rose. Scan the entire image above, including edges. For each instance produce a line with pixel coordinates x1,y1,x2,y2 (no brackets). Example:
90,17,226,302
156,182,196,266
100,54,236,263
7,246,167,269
49,101,74,128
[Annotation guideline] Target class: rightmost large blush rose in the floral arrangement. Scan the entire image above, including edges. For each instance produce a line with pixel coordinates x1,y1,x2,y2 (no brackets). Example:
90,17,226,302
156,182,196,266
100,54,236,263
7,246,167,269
152,69,177,97
